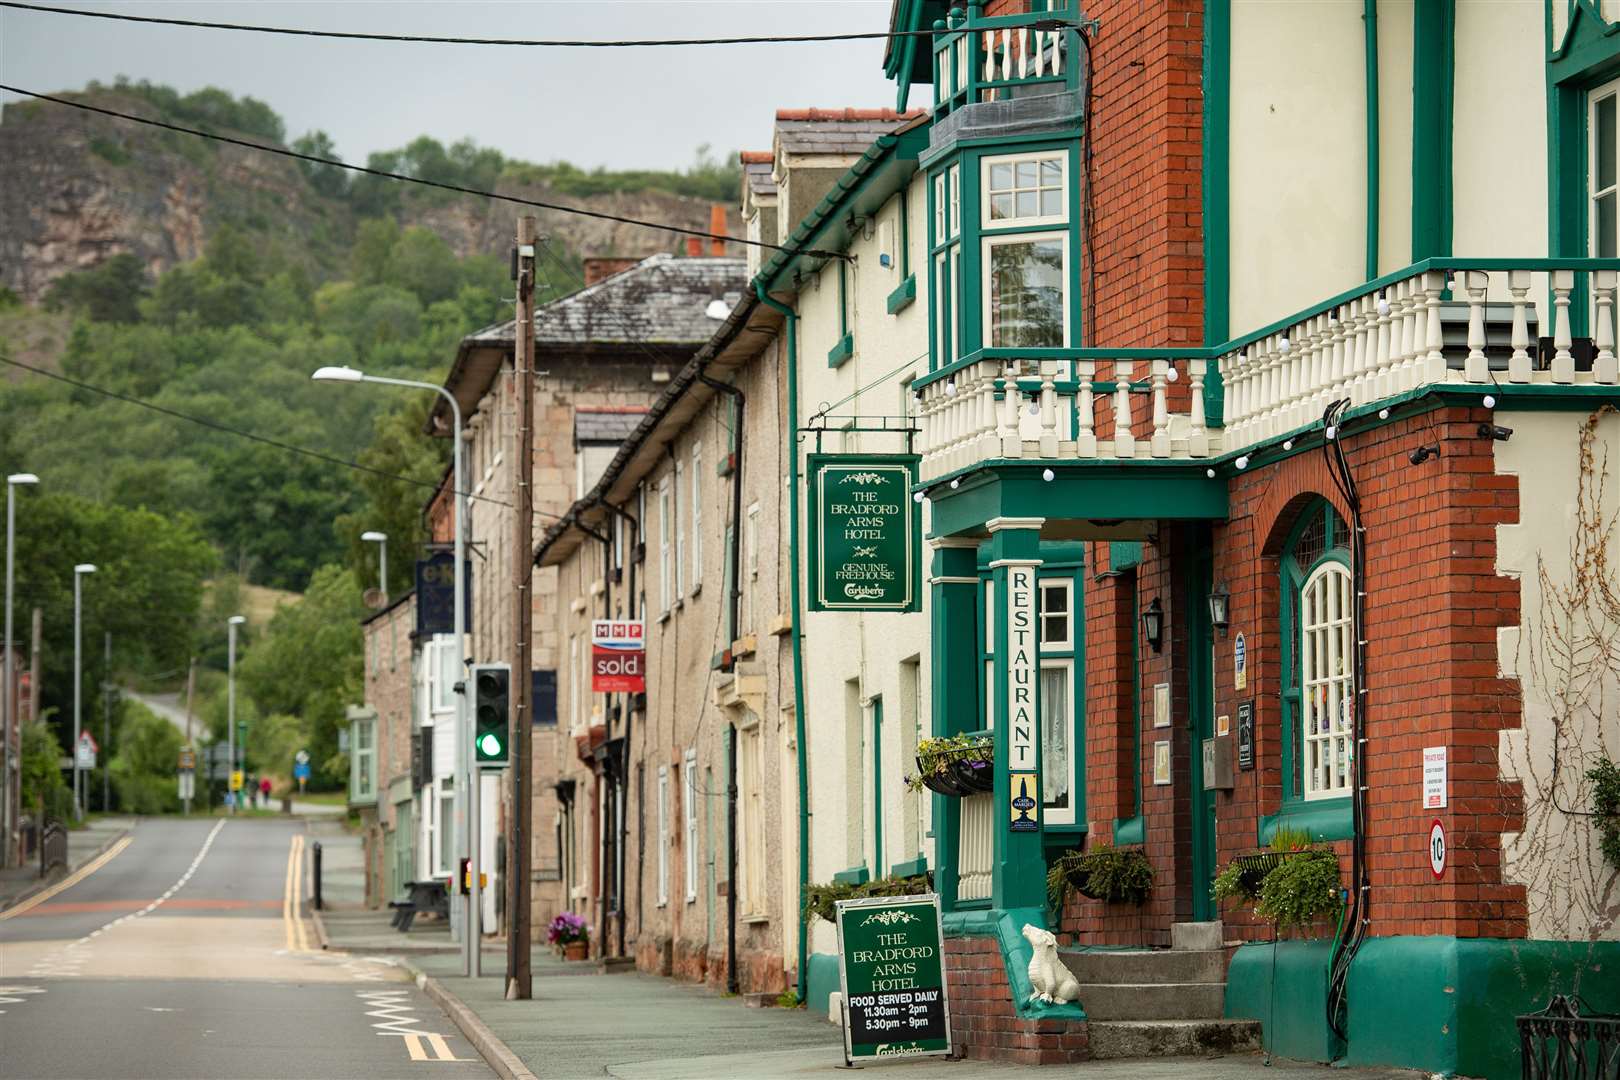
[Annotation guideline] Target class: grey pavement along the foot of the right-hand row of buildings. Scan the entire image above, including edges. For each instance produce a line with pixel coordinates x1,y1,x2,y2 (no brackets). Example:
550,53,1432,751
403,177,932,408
311,826,1419,1080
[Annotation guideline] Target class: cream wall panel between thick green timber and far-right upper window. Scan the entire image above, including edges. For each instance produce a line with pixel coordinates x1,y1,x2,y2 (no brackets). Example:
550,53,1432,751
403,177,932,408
1452,0,1547,259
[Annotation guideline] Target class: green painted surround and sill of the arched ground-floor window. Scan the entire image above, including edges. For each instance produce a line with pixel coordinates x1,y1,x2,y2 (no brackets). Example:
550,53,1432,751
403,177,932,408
1256,499,1359,845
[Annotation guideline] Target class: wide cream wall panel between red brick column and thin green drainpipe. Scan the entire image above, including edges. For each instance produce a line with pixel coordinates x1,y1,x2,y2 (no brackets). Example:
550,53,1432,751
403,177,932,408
1231,0,1367,334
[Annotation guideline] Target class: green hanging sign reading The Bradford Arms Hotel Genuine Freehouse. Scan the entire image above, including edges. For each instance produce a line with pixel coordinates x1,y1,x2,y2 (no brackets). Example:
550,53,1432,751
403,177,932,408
808,453,922,612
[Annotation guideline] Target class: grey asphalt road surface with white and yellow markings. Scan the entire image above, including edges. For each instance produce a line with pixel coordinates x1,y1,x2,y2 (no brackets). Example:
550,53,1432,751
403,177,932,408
0,819,492,1080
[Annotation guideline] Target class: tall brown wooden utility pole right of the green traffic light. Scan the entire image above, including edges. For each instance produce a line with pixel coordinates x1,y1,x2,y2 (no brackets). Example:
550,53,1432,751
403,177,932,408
505,215,538,1001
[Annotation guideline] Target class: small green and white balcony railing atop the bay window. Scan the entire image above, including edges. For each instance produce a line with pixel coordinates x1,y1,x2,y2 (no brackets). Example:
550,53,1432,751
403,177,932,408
933,3,1079,120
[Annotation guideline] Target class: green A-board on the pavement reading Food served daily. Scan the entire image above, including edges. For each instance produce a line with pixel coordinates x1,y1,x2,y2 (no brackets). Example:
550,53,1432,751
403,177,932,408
836,894,951,1064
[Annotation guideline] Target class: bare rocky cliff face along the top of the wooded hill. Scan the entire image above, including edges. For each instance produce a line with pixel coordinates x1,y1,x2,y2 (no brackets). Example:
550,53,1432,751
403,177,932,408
0,91,740,303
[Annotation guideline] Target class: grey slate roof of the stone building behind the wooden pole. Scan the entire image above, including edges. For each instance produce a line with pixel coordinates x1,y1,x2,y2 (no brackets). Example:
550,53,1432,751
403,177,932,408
462,254,748,350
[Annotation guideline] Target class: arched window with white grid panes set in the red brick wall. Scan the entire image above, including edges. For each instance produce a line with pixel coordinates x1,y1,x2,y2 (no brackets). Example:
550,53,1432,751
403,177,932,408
1281,500,1356,801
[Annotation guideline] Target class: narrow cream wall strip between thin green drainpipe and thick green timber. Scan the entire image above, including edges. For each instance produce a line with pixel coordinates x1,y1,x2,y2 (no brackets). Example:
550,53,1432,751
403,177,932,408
1379,0,1413,274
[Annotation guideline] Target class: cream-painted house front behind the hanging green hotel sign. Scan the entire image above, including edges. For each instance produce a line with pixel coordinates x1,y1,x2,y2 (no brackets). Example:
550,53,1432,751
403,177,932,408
781,173,935,952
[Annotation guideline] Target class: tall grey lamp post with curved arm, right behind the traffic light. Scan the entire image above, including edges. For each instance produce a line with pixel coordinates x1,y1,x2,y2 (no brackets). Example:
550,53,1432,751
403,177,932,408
309,368,481,978
